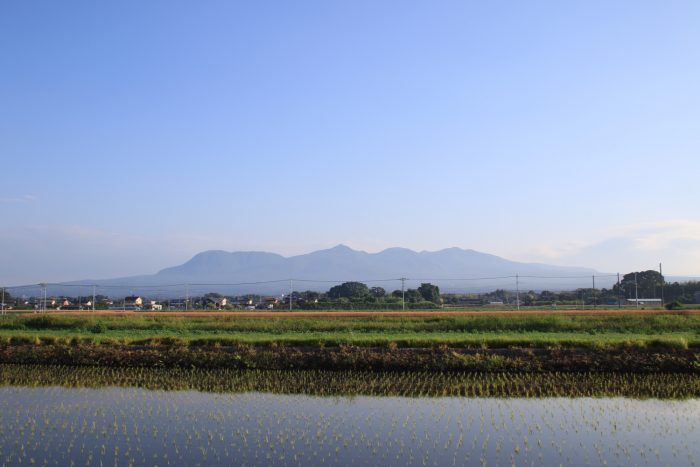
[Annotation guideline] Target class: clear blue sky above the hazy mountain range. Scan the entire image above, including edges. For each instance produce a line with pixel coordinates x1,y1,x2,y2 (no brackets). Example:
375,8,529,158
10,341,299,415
0,0,700,285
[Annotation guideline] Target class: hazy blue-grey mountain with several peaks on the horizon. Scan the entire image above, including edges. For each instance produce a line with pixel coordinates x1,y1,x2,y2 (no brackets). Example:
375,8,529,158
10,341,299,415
45,245,613,297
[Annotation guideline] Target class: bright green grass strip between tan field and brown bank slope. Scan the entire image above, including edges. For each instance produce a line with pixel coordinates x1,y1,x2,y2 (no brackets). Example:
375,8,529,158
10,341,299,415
0,315,700,348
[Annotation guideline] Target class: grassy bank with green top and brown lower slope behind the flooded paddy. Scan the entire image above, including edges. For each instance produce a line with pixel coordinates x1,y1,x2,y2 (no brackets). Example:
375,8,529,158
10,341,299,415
0,315,700,372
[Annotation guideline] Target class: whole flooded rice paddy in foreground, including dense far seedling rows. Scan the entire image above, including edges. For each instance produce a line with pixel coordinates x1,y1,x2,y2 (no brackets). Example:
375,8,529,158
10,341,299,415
0,365,700,466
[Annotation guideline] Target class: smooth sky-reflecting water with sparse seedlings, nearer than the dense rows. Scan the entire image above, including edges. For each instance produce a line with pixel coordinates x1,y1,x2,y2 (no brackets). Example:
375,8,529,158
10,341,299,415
0,387,700,466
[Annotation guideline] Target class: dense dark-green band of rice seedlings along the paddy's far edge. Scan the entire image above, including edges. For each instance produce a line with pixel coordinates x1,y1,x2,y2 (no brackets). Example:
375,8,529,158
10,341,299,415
0,365,700,399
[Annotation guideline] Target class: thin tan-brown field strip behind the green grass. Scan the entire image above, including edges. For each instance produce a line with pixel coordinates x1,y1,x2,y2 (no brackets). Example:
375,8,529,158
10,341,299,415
5,309,700,318
